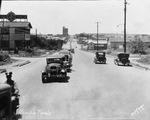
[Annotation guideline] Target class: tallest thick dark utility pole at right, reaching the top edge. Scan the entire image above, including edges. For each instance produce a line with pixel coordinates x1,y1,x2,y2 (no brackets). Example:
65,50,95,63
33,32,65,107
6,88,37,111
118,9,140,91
124,0,127,53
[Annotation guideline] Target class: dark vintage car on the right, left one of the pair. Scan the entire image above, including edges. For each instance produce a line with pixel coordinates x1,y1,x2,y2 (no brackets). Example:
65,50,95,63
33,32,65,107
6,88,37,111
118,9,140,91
94,51,106,64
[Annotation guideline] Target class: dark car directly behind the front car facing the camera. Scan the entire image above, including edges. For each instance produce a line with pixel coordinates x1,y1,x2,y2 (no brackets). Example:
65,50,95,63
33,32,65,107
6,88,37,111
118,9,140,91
59,50,73,70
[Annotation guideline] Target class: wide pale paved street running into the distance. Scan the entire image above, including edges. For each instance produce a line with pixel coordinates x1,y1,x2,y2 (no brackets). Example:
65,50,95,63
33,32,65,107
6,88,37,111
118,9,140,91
0,42,150,120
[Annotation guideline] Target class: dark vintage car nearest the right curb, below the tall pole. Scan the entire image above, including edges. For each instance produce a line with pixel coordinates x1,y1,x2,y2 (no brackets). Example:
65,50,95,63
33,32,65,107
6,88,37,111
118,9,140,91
114,53,130,66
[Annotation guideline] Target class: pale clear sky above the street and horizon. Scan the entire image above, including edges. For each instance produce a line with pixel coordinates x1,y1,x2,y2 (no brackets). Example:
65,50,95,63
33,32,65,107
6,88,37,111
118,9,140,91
0,0,150,35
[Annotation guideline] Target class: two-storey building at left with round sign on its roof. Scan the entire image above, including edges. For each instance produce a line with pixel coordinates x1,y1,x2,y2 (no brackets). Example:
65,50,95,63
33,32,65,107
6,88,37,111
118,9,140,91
0,12,32,50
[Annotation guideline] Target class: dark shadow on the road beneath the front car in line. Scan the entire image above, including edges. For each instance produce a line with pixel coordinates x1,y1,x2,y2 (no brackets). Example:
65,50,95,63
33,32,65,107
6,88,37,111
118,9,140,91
47,76,70,83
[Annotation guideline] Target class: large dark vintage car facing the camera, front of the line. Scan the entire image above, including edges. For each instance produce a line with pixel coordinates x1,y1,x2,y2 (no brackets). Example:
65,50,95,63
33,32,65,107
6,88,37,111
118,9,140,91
42,55,67,83
